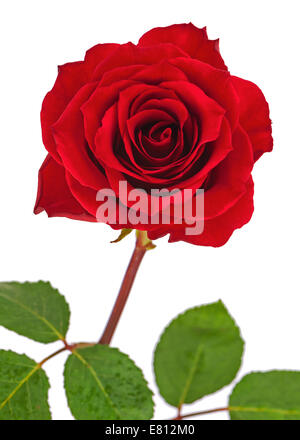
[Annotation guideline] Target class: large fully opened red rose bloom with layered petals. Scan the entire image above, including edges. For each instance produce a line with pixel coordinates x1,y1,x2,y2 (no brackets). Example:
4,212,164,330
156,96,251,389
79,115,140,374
35,24,272,246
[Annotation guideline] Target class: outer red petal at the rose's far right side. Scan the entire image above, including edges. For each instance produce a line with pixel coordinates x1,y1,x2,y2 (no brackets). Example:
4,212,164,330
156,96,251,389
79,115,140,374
232,76,273,161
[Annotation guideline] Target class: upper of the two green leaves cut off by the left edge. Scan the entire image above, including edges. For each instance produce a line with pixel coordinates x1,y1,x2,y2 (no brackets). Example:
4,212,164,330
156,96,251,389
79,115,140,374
0,281,70,343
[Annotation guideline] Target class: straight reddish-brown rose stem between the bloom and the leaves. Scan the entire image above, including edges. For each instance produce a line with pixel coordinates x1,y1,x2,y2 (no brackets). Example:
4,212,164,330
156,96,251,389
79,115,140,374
98,231,153,345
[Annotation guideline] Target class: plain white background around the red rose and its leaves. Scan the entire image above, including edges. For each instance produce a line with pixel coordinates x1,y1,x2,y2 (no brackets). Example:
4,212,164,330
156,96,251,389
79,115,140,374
0,0,300,419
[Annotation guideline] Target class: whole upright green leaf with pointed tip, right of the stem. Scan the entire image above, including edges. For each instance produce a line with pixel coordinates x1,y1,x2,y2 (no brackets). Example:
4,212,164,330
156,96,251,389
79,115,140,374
154,301,244,408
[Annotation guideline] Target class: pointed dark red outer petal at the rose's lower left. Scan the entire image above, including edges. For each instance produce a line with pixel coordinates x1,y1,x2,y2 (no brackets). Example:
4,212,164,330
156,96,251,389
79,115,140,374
34,154,96,222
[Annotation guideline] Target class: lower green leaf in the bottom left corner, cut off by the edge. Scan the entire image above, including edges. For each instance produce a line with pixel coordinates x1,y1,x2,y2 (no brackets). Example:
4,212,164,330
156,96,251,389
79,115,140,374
0,350,51,420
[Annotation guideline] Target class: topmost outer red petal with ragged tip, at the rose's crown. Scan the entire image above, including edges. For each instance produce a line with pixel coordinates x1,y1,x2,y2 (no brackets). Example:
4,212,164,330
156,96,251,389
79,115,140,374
138,23,227,70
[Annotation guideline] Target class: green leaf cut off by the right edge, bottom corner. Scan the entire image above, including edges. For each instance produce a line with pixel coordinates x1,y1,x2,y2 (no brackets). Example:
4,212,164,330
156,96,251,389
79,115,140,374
229,371,300,420
